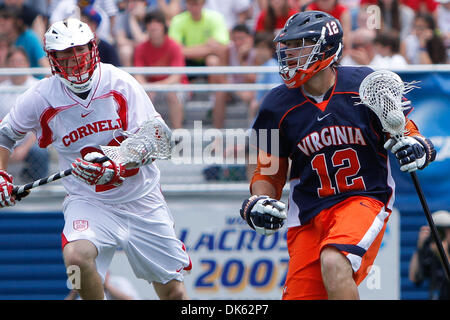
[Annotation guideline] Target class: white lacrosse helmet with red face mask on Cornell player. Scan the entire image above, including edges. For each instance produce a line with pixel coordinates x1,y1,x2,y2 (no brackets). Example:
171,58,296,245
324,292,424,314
44,18,100,93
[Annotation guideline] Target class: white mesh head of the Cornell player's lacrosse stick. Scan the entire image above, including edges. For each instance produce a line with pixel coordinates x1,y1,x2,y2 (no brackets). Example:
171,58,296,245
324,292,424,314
100,118,172,167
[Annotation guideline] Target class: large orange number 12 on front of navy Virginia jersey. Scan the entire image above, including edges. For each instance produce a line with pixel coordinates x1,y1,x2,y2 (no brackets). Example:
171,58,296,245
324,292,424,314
311,148,366,198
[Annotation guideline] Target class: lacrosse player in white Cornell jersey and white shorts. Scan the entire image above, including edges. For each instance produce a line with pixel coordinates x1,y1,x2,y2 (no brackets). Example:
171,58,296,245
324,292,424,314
0,18,191,299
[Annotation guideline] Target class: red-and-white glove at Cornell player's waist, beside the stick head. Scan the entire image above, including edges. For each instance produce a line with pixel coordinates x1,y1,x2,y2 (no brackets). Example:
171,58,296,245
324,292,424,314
71,152,125,186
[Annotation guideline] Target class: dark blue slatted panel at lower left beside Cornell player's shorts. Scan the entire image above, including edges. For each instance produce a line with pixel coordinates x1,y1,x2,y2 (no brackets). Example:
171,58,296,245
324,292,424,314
0,212,69,300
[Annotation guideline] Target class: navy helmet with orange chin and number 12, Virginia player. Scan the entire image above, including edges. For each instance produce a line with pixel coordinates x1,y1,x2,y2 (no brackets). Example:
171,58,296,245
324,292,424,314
274,11,343,88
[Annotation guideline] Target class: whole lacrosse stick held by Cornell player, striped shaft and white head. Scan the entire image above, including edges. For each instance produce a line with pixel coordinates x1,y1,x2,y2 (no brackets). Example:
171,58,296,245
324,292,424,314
12,118,172,200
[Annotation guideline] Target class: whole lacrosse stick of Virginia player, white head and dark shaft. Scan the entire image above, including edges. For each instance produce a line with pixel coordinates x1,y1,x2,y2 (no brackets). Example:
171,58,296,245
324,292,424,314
359,70,450,279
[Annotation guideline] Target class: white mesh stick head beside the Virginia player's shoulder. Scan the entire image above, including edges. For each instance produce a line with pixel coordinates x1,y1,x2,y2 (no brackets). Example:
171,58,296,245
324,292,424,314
359,70,409,136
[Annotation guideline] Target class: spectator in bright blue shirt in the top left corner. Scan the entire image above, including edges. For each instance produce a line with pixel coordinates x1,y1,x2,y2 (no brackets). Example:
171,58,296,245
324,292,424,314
0,6,49,68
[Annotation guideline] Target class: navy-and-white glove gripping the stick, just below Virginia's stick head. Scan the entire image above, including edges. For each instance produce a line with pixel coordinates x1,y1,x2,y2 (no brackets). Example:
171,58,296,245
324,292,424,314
384,136,436,172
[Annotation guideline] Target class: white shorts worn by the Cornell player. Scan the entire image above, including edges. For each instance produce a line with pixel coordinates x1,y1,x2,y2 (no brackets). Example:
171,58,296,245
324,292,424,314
62,185,192,283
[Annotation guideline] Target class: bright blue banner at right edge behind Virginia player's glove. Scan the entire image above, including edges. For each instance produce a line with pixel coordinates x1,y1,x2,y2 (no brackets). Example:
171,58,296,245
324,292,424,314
391,71,450,211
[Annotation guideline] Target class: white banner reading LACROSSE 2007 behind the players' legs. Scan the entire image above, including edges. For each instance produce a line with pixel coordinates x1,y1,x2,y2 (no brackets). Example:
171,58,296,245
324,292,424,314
110,195,400,300
